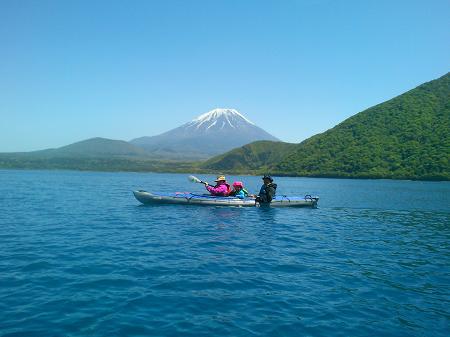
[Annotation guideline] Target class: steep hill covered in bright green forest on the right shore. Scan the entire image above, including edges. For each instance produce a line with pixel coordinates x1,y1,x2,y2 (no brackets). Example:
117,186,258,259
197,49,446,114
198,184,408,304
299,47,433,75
207,74,450,180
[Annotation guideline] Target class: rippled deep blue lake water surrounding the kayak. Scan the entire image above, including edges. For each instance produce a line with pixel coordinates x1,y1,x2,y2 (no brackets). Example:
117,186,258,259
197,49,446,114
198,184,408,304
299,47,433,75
0,171,450,337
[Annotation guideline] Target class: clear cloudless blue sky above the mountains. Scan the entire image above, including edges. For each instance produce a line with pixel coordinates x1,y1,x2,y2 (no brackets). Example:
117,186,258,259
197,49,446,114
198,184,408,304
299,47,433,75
0,0,450,151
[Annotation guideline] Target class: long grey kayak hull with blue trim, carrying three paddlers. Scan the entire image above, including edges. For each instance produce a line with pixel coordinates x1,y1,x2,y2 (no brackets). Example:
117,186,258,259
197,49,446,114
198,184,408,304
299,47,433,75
133,190,319,207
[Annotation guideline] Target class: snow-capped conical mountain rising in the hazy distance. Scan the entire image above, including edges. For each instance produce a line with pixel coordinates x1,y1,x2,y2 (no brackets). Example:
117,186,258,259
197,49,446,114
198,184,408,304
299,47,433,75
130,109,278,160
